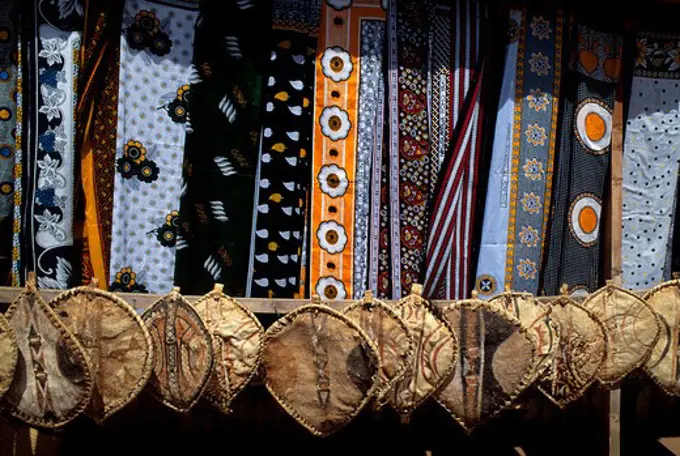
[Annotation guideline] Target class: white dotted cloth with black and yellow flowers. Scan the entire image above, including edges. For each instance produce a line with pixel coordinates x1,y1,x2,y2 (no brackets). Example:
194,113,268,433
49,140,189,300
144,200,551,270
109,0,198,294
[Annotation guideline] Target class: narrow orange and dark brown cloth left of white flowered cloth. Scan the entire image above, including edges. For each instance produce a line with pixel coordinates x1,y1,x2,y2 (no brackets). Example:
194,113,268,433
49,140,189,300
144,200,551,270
76,0,123,289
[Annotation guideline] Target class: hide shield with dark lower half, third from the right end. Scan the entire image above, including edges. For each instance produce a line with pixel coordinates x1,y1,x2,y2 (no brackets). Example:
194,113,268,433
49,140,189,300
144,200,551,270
539,297,607,408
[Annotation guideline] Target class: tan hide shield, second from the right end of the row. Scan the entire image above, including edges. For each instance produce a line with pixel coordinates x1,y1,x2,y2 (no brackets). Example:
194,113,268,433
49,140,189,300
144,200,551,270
583,285,660,384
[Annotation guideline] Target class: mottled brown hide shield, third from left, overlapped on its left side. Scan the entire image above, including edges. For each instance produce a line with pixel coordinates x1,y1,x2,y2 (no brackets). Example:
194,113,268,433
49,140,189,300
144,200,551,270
50,287,153,423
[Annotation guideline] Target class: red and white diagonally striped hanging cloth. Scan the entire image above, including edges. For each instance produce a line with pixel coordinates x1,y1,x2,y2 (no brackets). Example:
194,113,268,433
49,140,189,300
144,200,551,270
425,0,485,299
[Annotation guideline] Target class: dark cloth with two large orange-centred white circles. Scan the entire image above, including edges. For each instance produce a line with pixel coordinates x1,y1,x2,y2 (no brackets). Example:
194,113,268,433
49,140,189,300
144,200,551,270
543,25,623,296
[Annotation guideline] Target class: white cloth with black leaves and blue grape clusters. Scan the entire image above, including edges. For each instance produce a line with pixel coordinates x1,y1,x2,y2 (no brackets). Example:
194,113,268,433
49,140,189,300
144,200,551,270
23,0,83,289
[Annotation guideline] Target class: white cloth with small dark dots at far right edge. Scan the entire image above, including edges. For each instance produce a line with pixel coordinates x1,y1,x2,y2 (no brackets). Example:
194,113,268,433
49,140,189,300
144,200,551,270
622,33,680,289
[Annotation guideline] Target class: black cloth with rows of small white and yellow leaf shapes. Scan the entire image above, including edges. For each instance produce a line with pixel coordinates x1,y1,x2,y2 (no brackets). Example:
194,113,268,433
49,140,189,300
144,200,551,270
246,0,321,298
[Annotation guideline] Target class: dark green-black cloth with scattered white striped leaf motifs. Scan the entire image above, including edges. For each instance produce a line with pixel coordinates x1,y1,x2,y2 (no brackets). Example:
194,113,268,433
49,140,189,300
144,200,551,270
175,0,268,296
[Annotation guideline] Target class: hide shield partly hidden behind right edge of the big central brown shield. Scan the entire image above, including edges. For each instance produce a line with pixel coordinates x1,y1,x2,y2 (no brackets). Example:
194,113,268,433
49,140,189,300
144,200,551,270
343,298,415,404
